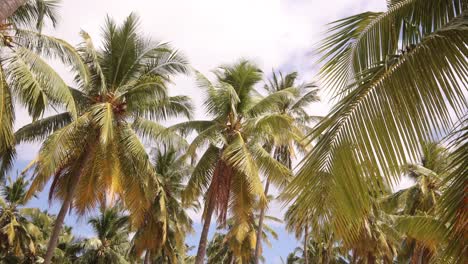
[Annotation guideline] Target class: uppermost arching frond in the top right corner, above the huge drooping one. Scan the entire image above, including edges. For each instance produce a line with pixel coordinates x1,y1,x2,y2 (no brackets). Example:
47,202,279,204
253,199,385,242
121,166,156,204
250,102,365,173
319,0,467,93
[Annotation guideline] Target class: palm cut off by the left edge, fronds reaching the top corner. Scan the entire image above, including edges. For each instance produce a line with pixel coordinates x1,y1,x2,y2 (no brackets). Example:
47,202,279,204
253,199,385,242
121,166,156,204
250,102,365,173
0,0,73,179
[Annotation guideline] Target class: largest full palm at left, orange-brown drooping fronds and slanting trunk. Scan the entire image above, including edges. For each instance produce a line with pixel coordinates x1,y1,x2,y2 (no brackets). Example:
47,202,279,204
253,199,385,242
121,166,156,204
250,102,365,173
16,14,192,264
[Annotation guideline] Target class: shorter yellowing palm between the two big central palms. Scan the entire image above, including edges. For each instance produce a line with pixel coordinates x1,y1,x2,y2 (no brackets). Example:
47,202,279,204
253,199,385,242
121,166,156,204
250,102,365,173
132,145,193,263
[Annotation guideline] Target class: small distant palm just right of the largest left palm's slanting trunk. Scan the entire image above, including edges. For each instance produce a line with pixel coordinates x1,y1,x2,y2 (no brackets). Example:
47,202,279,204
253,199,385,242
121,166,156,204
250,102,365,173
77,206,130,264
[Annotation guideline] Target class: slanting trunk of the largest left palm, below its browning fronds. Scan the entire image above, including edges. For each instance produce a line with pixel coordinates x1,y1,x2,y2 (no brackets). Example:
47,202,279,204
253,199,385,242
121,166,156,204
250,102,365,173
44,171,81,264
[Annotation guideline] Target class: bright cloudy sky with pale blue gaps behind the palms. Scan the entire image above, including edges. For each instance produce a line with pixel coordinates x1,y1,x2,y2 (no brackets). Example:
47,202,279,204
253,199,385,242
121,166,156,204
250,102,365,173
11,0,392,264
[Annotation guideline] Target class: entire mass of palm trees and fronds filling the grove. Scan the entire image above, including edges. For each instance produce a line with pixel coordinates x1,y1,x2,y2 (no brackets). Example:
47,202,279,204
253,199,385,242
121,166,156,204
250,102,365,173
0,0,468,264
